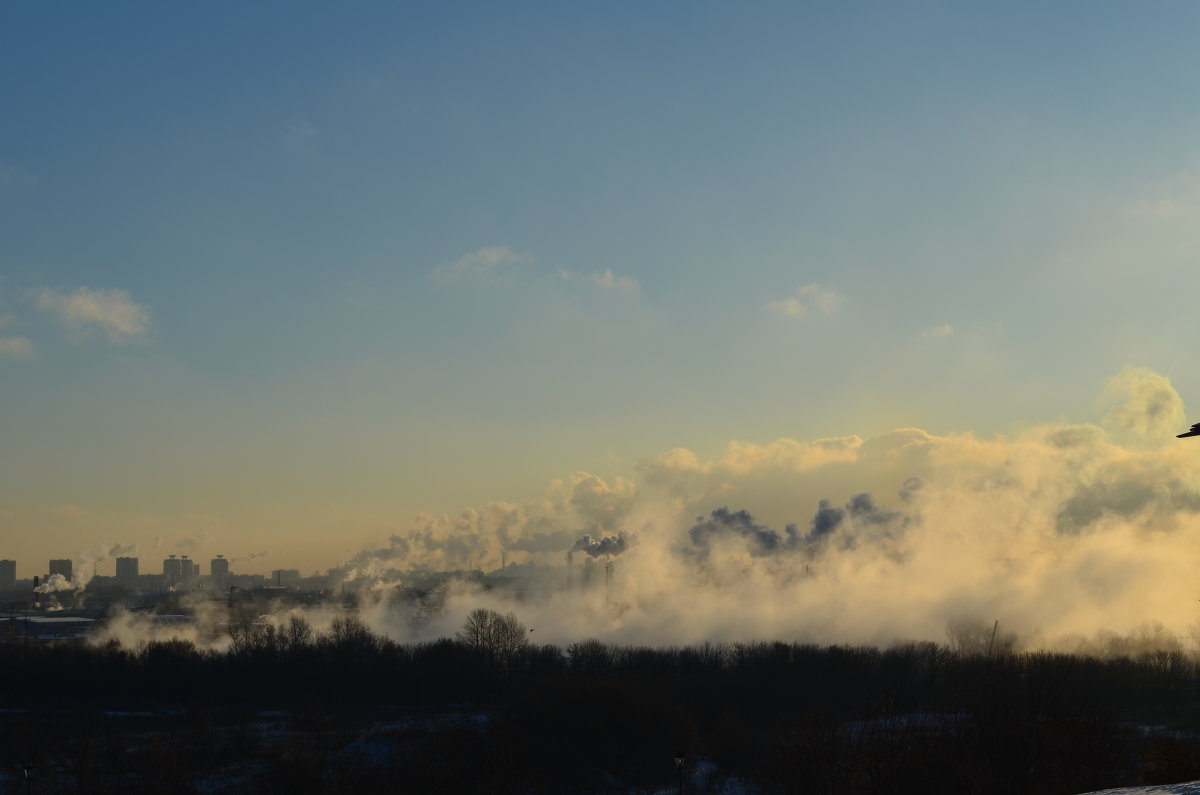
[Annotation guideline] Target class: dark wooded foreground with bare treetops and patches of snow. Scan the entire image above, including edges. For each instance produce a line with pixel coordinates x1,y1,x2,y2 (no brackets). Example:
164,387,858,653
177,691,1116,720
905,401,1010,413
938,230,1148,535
0,616,1200,795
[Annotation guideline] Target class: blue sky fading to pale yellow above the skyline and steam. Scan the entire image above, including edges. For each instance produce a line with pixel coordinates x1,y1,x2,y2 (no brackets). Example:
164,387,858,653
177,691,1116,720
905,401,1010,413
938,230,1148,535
0,1,1200,590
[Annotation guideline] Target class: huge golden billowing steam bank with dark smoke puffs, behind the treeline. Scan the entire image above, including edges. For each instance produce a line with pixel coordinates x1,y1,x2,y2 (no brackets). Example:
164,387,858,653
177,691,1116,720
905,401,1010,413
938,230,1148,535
334,369,1200,646
